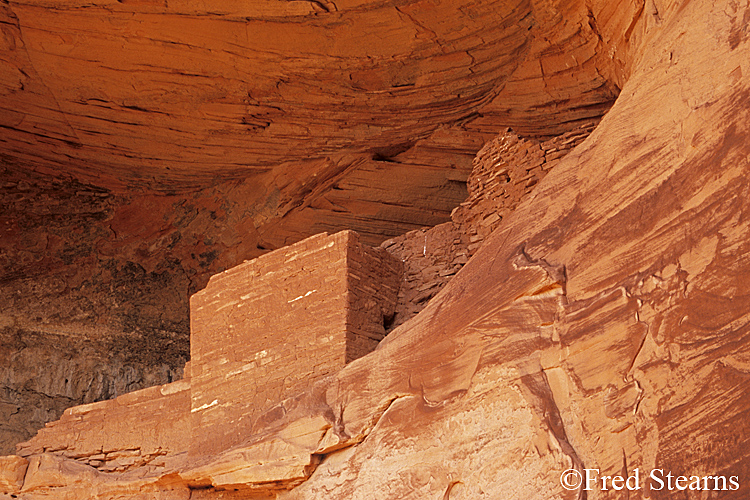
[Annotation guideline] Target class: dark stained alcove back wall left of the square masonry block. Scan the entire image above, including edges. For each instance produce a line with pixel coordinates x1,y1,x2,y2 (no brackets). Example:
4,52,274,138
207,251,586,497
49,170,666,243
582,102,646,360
0,173,262,452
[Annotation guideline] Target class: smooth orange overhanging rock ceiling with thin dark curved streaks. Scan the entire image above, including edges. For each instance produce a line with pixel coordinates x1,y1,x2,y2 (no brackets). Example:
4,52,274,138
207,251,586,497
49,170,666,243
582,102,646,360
0,0,616,191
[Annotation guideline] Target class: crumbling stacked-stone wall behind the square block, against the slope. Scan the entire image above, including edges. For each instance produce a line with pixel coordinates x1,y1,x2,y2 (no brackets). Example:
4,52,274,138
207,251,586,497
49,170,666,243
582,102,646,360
381,124,595,329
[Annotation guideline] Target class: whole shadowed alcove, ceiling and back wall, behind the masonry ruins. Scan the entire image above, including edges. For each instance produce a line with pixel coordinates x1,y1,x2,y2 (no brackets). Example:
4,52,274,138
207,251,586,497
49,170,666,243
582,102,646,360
0,0,636,452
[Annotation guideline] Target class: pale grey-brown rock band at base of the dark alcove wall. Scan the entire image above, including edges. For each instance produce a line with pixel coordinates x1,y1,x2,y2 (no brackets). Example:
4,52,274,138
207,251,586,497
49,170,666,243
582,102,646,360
0,328,183,458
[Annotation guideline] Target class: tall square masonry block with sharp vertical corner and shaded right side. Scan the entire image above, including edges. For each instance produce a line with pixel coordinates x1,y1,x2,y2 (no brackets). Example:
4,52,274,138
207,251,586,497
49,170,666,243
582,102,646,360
190,231,403,454
